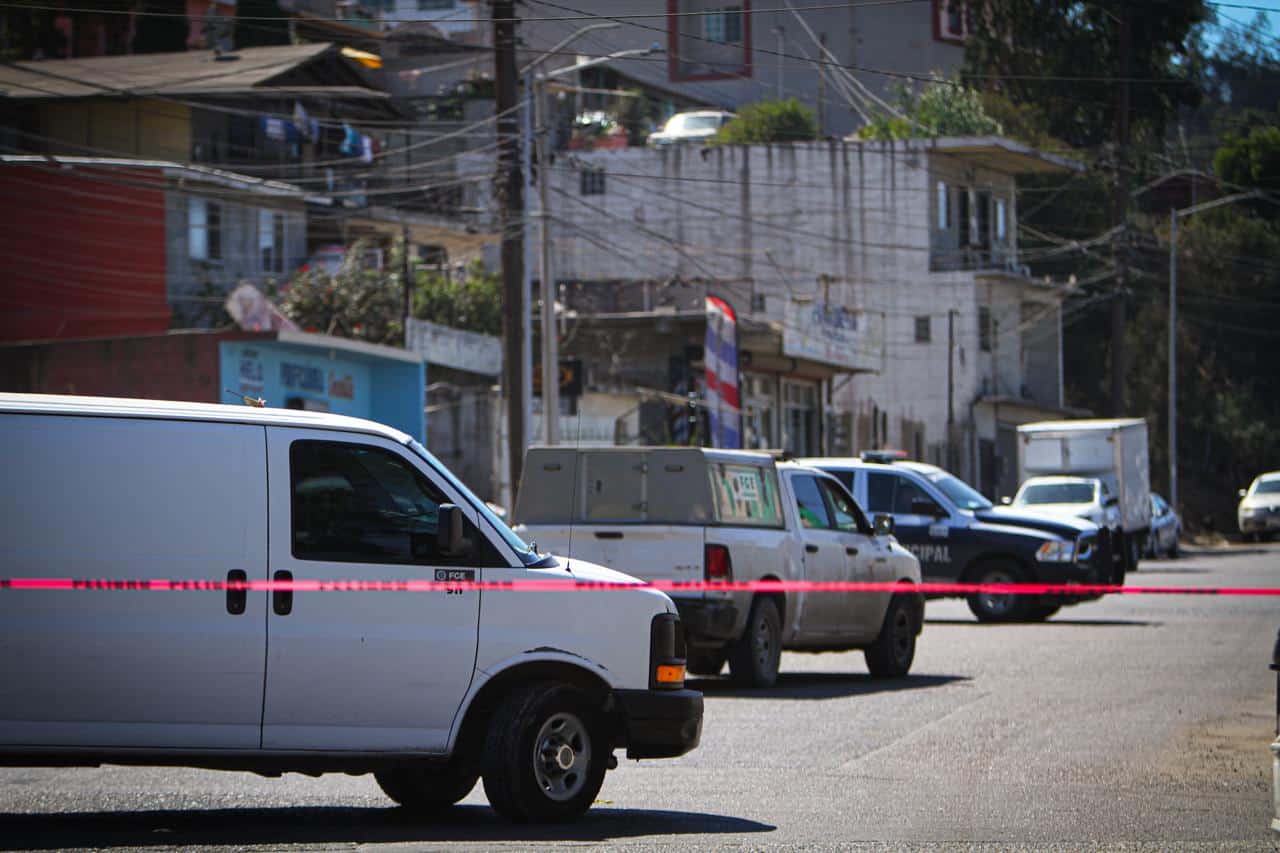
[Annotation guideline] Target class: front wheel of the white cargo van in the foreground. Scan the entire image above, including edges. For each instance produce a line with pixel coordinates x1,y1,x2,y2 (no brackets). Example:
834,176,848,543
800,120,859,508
483,681,612,824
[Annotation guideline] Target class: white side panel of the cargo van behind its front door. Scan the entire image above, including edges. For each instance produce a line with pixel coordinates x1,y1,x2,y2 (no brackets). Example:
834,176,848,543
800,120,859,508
0,414,268,749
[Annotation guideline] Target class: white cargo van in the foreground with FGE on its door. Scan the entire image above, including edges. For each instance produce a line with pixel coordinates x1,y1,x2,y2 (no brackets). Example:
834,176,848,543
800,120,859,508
0,394,703,821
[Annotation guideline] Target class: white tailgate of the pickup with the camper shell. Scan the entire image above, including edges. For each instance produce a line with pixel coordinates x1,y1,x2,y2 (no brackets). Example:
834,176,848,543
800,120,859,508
521,524,705,594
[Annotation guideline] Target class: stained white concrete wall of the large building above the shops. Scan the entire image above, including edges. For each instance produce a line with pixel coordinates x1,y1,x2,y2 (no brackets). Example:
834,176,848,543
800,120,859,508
494,142,1057,475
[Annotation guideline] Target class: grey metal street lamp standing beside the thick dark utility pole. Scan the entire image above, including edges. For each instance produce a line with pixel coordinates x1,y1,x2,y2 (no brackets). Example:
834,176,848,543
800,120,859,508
532,42,662,444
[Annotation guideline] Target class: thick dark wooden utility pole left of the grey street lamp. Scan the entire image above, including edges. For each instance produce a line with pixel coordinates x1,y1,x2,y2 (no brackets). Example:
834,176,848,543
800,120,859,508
492,0,529,502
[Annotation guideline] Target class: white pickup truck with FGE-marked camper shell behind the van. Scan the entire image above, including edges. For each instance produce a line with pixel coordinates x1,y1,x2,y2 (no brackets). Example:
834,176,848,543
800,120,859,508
515,447,924,686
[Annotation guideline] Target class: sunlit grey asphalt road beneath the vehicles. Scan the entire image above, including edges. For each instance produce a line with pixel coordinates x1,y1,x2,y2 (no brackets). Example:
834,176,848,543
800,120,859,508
0,546,1280,849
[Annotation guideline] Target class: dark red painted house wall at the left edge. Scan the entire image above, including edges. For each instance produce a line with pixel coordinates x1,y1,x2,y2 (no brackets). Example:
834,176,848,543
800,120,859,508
0,164,169,341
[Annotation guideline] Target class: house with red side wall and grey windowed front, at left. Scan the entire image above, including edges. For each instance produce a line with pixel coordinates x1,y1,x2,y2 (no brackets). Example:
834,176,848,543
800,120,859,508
0,156,307,341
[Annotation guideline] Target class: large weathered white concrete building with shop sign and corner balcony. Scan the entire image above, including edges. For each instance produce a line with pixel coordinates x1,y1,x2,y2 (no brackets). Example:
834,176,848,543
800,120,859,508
477,137,1078,494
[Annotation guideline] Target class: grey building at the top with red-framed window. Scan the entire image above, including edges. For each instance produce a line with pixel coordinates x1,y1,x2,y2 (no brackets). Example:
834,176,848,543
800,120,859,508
518,0,972,136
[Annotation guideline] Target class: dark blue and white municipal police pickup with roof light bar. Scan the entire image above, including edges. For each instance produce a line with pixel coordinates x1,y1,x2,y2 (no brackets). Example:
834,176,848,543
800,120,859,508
799,452,1112,622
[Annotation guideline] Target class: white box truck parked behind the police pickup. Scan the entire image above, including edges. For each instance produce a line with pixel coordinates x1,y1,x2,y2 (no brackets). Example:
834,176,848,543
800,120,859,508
1014,418,1151,569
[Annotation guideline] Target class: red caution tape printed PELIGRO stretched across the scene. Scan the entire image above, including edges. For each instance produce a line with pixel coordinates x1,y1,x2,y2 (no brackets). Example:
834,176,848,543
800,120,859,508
0,576,1280,597
